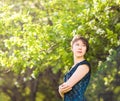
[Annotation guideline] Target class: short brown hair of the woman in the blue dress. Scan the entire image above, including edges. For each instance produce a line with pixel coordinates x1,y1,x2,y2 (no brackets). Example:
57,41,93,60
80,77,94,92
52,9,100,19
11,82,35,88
71,35,89,52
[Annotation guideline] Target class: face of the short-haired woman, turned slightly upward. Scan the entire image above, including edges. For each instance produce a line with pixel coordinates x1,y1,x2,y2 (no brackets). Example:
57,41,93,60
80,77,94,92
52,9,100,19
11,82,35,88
72,40,87,57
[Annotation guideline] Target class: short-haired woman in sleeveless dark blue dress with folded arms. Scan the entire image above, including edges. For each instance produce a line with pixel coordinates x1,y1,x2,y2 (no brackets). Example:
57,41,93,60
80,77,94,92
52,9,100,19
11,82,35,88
59,35,91,101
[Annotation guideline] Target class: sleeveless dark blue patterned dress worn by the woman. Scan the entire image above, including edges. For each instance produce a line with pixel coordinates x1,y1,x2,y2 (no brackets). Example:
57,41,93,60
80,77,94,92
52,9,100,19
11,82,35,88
64,60,91,101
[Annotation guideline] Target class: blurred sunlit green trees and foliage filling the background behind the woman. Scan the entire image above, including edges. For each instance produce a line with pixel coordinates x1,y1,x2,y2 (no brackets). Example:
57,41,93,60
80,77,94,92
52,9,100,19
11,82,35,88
0,0,120,101
